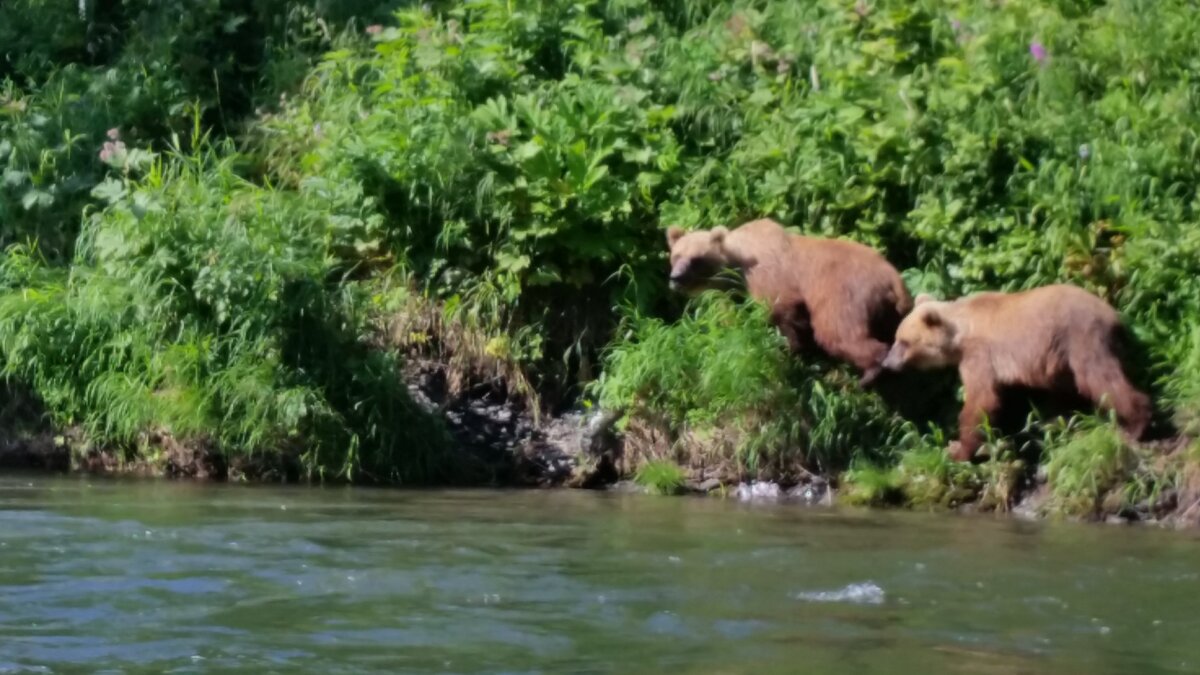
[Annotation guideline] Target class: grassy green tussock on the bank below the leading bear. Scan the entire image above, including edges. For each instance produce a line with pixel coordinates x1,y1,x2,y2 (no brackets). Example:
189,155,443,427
594,292,914,478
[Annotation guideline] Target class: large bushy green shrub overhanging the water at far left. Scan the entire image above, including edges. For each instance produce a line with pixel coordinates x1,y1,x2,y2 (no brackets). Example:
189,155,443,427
0,138,443,480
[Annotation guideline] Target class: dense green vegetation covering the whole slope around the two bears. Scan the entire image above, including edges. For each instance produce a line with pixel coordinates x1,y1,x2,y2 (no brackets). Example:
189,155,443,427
7,0,1200,514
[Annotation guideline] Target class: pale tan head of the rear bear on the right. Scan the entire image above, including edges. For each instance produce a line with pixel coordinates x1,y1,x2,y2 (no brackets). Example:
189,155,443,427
882,293,962,371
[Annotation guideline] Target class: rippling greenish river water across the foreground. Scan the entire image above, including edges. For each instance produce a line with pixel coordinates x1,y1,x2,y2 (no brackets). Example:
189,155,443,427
0,476,1200,675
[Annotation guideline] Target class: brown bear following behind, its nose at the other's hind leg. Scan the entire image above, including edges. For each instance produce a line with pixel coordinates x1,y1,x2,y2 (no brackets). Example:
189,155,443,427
883,285,1152,461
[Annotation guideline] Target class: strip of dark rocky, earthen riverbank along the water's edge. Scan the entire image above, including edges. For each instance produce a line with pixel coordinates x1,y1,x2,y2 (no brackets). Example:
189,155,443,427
0,359,1200,528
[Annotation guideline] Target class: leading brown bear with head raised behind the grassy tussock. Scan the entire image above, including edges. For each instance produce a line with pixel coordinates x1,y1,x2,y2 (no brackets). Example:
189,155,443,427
667,219,912,387
